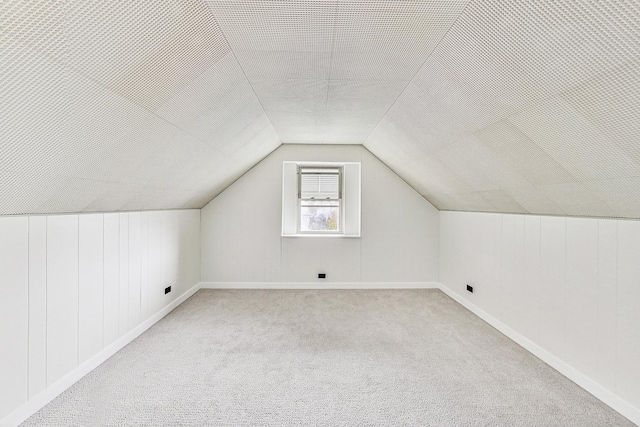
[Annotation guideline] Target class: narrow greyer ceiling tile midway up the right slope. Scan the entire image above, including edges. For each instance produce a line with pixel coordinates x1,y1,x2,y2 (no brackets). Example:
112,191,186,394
474,121,575,185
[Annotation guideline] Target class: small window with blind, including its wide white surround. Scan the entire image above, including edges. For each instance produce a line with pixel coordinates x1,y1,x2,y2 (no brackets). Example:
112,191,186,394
282,162,360,237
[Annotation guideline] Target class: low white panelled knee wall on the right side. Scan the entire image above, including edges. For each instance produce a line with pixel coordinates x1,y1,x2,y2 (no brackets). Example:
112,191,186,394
440,212,640,420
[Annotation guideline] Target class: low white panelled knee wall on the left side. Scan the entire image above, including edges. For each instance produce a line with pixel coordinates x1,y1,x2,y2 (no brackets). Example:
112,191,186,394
0,210,200,420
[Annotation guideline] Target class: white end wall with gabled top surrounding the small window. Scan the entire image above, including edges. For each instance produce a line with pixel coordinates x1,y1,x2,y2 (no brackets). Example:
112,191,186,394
202,145,438,284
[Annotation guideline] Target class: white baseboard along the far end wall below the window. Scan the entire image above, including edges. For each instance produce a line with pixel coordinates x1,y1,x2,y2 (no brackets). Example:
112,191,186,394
200,282,440,289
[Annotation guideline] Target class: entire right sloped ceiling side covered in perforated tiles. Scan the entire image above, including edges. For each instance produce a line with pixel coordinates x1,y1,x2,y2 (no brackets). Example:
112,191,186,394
364,0,640,218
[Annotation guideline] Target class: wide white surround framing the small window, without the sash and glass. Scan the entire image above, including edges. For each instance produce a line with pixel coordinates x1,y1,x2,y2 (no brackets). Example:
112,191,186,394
282,161,361,238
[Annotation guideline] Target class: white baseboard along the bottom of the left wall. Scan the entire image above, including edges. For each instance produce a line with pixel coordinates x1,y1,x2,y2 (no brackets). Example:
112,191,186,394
0,284,200,426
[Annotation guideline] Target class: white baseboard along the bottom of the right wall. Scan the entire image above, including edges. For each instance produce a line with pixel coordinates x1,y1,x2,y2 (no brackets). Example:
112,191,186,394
440,283,640,425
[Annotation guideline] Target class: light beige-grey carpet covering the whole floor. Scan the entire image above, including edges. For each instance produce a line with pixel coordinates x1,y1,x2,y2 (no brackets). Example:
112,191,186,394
23,290,634,427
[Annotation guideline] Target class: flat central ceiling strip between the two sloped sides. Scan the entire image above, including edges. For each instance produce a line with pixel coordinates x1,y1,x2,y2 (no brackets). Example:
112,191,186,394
207,0,467,144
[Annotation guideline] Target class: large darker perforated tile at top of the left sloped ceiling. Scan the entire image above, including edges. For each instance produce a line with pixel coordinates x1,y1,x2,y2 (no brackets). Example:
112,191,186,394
64,1,230,111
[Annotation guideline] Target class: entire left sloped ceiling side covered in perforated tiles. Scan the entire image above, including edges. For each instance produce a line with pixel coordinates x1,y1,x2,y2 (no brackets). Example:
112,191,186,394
0,0,280,214
